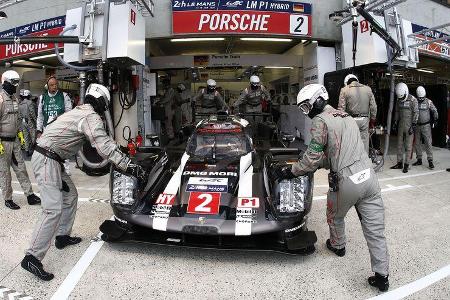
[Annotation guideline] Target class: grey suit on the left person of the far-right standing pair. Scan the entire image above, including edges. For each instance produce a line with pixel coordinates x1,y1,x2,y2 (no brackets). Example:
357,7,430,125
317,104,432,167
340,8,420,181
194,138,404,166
395,95,419,164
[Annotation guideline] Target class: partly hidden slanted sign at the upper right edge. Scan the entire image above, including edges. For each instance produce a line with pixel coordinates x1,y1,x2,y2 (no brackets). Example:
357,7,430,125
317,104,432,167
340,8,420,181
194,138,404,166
412,24,450,59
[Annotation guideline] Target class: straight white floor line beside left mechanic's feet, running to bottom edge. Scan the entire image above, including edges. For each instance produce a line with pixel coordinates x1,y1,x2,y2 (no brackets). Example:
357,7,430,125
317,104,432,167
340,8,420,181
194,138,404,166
50,233,105,300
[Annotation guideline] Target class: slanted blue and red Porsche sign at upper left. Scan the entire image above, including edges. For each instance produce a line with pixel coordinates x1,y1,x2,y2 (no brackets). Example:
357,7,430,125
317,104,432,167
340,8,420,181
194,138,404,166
0,16,66,60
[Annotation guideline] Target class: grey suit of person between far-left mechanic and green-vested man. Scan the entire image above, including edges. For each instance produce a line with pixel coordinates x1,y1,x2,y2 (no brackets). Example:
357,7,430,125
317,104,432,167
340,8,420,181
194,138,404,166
19,99,37,151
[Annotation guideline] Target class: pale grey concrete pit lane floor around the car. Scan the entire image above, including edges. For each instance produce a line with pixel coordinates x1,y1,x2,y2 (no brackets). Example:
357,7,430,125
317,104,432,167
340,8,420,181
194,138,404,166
0,148,450,299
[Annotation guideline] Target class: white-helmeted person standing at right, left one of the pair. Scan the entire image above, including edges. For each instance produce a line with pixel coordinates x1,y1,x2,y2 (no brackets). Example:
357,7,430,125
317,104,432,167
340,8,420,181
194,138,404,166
391,82,419,173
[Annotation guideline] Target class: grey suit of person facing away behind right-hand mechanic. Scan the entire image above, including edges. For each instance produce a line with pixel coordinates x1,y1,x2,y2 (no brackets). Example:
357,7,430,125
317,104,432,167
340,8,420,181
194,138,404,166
338,81,377,152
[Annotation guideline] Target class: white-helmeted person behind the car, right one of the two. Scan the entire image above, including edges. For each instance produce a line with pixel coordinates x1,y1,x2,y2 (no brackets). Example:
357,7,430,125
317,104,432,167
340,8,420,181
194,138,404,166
233,75,271,117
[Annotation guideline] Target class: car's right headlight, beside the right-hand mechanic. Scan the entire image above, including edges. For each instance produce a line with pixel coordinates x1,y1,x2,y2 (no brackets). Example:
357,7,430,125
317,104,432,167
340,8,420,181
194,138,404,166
276,176,309,214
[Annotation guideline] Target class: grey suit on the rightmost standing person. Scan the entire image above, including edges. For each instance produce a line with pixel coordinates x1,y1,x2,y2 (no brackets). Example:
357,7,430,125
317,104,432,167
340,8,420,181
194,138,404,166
415,98,439,160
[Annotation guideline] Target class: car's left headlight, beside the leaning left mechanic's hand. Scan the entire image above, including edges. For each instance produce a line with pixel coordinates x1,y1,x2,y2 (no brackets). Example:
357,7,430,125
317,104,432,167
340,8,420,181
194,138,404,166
112,171,137,205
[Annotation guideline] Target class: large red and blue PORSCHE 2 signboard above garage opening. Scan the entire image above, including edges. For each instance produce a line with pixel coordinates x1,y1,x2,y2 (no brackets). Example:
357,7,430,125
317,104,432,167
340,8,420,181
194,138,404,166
172,0,312,36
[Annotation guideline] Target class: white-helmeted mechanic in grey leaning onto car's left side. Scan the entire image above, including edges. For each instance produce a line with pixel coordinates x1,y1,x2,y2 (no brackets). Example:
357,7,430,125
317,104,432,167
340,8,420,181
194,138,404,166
21,84,142,281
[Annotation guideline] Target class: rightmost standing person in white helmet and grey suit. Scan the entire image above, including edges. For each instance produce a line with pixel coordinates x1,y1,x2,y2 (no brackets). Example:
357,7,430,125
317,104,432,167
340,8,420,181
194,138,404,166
413,86,439,169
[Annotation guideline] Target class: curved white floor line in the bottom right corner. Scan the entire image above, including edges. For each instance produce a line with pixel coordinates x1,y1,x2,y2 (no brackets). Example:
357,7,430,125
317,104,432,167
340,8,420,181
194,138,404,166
368,265,450,300
